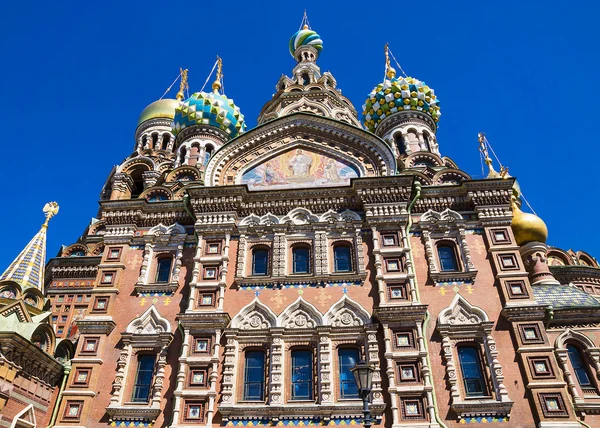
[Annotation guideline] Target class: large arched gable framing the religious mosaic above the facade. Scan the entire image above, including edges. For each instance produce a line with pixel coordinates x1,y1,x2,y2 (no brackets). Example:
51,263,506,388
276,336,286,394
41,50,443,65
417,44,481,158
205,113,396,190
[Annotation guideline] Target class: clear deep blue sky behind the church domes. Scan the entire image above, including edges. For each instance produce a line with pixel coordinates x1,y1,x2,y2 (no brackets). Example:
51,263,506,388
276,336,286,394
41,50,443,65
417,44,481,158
0,0,600,269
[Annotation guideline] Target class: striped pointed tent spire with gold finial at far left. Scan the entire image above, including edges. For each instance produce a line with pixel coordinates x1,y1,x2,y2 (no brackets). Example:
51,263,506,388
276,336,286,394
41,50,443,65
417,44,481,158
0,202,58,292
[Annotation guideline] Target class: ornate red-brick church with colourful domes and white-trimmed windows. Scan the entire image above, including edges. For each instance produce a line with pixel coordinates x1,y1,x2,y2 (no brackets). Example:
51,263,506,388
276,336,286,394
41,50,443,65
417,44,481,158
0,21,600,428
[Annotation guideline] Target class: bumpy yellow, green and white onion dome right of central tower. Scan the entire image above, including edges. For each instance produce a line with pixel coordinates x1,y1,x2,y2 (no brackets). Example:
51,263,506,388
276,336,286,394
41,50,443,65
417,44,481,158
363,74,441,132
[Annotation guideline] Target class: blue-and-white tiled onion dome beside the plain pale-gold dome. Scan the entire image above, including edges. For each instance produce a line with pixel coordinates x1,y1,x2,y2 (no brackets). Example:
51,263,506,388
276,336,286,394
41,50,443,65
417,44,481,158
172,91,246,138
